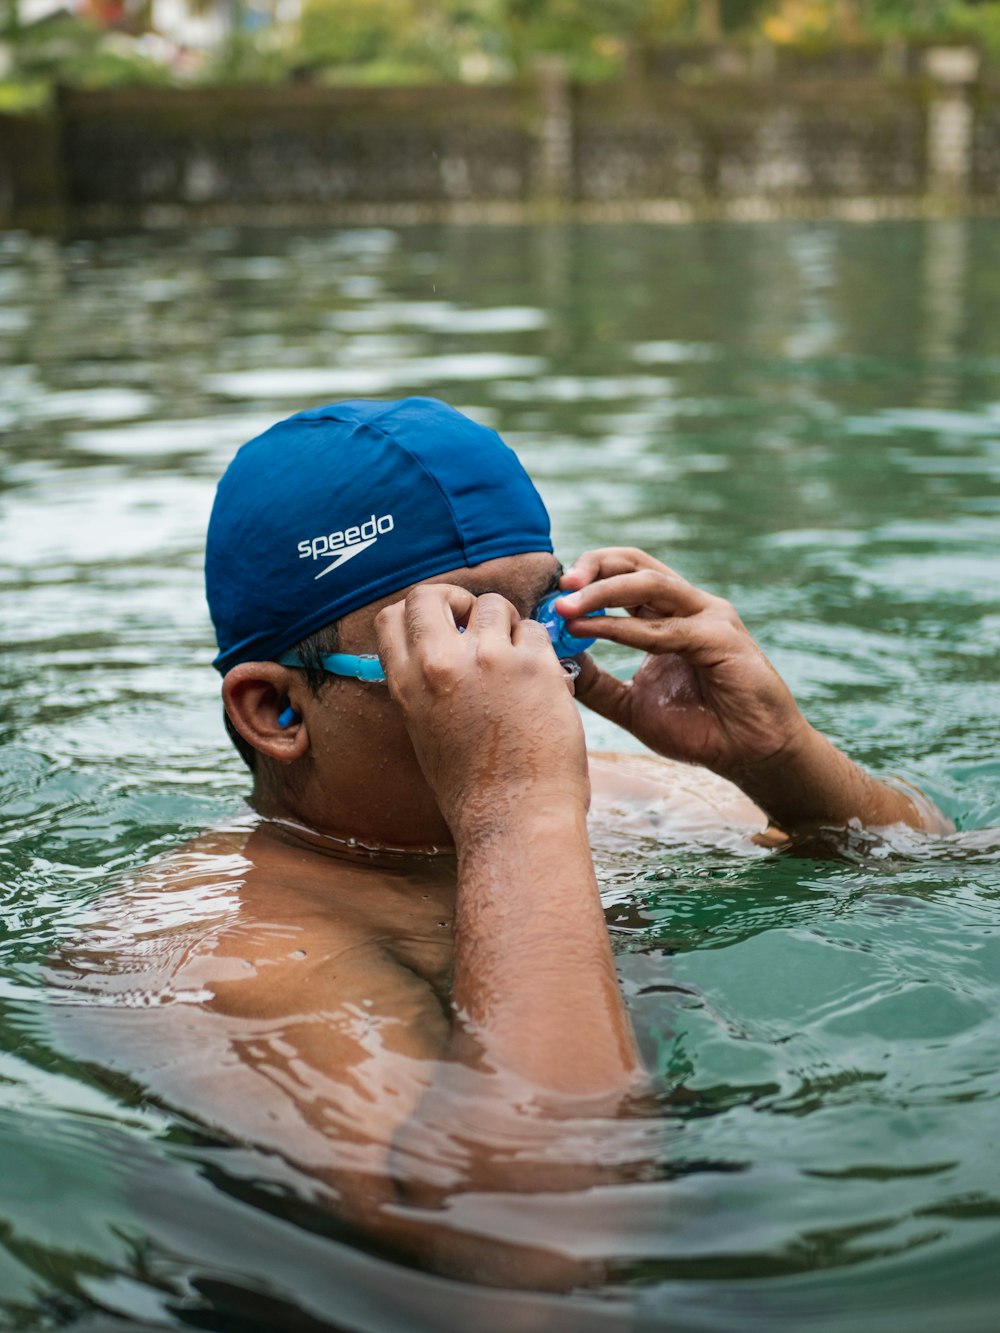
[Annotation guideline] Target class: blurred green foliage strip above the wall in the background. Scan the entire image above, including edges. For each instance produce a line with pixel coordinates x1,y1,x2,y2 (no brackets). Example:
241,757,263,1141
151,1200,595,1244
0,0,1000,96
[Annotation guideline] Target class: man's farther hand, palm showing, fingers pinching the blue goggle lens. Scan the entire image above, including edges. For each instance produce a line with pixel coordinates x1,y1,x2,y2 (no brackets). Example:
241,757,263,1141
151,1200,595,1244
556,547,808,778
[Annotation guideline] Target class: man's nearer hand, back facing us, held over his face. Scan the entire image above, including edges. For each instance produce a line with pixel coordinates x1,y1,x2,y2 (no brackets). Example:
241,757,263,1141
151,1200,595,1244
376,584,589,841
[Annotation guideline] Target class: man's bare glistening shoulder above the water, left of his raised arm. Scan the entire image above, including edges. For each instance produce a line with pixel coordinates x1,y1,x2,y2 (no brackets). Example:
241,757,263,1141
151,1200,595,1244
52,820,452,1017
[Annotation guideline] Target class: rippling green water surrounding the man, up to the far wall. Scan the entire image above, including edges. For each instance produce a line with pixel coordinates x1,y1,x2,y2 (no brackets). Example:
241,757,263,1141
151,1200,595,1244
0,221,1000,1333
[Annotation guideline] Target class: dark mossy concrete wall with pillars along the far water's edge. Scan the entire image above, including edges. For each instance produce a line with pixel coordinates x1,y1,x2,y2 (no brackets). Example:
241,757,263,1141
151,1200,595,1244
0,48,1000,227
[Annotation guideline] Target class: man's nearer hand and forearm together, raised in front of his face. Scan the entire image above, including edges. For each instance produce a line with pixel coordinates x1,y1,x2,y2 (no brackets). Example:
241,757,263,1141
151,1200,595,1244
377,585,639,1102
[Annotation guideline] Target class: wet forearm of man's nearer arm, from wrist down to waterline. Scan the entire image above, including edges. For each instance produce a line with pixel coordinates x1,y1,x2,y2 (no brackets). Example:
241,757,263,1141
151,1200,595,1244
452,793,639,1097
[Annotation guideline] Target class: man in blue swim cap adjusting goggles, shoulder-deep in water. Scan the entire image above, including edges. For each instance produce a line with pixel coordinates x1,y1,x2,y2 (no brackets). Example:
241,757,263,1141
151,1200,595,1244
58,399,943,1286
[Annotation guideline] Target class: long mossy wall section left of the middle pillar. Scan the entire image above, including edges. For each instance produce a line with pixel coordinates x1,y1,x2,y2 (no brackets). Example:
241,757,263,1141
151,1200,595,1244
59,87,532,223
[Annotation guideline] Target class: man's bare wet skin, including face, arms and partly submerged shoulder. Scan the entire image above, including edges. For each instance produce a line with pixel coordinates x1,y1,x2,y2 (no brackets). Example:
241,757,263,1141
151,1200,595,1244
49,551,954,1288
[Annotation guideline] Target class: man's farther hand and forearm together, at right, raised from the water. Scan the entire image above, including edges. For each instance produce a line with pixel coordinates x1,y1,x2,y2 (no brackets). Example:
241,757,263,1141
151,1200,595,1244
556,547,949,833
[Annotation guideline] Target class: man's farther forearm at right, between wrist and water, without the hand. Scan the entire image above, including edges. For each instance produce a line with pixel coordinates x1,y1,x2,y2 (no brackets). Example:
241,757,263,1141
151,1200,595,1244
727,726,951,833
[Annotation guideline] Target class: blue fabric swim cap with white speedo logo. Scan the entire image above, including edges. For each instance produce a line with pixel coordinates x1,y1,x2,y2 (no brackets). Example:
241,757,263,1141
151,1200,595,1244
205,399,552,673
